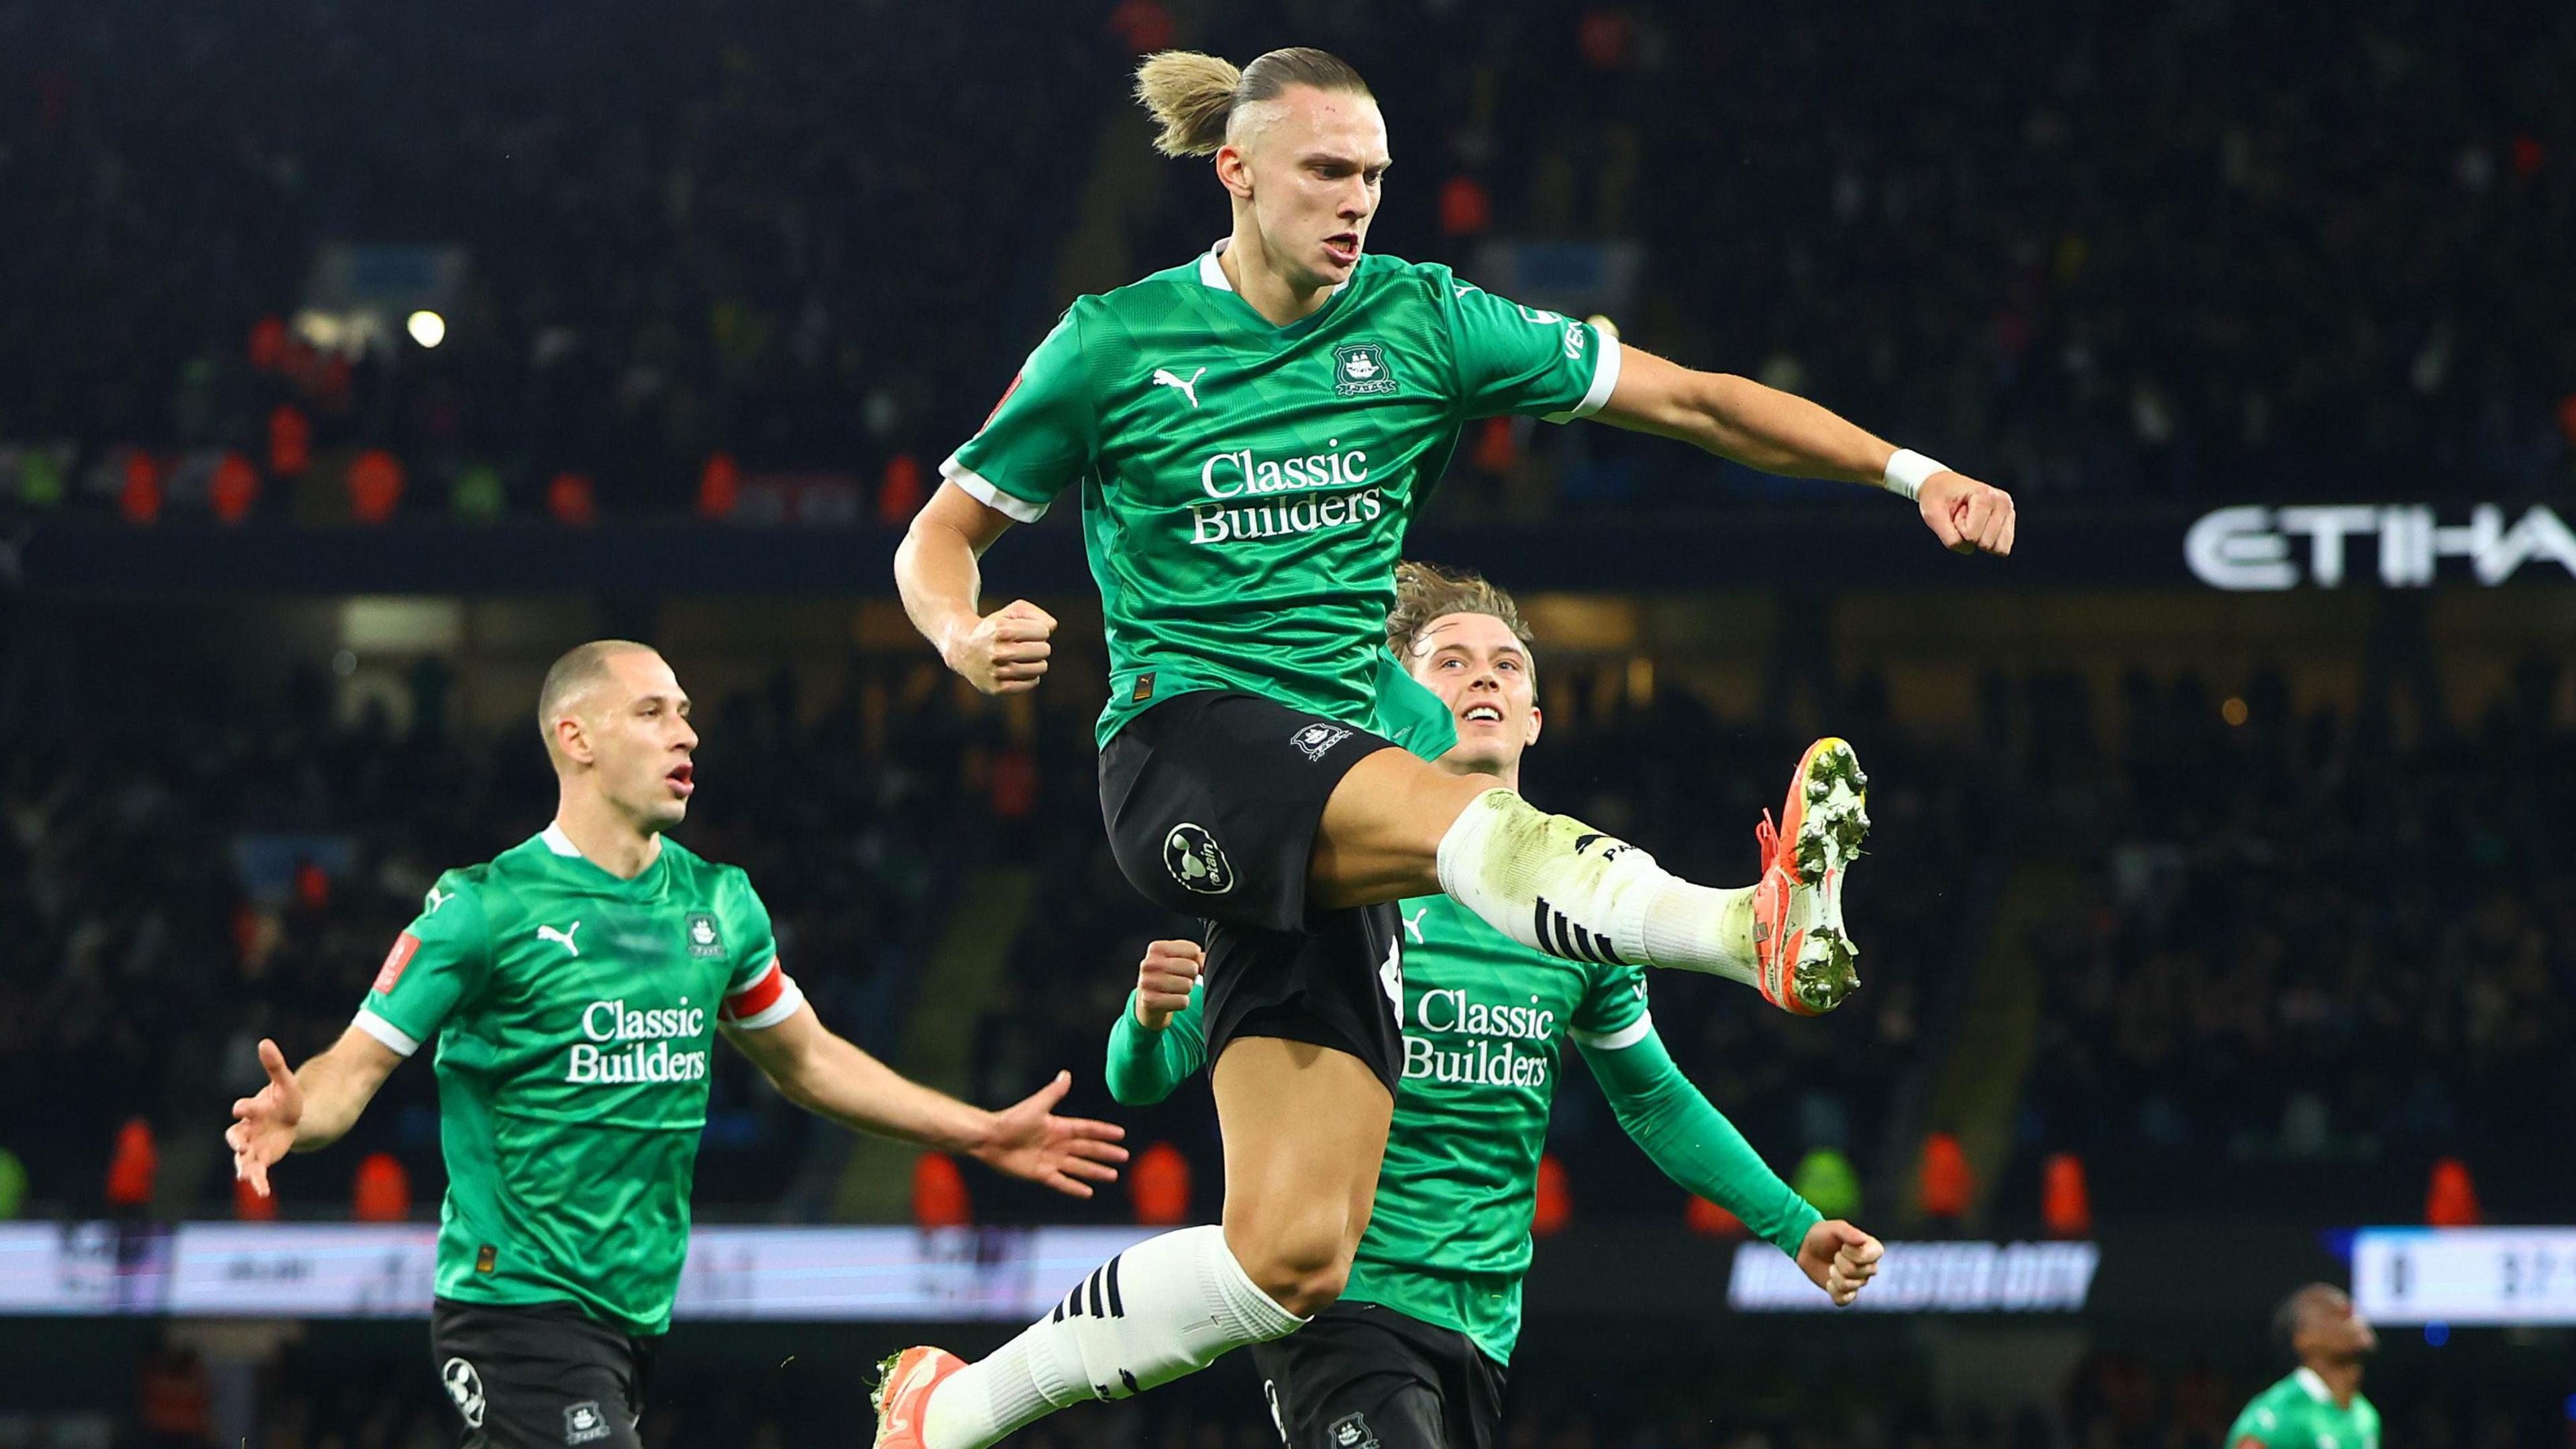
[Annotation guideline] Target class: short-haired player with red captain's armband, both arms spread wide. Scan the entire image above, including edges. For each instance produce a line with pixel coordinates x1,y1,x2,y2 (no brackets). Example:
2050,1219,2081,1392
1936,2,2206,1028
224,639,1126,1449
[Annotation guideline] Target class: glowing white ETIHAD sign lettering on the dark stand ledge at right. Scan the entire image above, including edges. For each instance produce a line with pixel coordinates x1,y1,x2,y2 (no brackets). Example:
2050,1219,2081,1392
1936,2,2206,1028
2182,502,2576,590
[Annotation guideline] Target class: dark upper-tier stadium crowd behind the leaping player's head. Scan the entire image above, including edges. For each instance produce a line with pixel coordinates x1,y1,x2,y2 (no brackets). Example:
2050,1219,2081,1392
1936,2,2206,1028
0,0,2576,521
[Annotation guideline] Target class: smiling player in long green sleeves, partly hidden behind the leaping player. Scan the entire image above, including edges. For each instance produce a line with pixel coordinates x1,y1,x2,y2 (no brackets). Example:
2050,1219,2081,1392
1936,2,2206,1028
1108,562,1880,1449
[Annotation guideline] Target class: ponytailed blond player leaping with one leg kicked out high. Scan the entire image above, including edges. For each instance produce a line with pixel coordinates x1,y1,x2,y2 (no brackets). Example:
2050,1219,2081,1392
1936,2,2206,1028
878,49,2015,1449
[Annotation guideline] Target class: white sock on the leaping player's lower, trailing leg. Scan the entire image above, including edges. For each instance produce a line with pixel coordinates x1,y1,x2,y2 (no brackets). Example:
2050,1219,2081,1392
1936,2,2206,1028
922,1227,1306,1449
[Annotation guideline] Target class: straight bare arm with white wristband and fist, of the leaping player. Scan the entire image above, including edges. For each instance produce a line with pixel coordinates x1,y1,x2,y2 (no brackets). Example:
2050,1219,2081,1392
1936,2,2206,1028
1597,348,2015,554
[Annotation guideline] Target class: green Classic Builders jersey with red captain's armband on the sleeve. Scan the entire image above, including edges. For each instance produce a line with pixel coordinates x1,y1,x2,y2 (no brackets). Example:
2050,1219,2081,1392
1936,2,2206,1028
358,825,804,1333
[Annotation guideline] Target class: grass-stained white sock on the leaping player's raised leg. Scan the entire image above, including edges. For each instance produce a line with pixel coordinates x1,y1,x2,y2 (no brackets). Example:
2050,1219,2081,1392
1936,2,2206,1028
1440,789,1757,985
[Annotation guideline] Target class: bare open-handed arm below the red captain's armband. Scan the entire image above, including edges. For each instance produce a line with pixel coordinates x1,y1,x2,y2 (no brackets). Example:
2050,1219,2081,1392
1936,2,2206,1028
727,1006,1126,1196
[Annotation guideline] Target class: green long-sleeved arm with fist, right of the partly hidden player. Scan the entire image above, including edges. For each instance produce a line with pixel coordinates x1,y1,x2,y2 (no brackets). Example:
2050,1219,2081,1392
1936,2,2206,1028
1585,1026,1880,1305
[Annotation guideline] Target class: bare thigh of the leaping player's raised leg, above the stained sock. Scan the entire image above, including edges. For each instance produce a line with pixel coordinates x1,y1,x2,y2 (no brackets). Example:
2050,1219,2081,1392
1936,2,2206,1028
1306,748,1502,910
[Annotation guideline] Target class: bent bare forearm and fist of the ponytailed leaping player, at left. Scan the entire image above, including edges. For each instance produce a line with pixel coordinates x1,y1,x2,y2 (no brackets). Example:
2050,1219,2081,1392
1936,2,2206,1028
894,482,1056,694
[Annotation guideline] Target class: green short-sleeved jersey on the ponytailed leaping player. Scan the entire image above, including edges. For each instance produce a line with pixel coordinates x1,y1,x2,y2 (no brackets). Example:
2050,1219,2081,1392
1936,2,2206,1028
941,242,1620,745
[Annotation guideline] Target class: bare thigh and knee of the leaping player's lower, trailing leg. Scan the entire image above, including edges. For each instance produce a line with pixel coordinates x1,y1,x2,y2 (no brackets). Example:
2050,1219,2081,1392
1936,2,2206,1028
1208,1036,1396,1318
